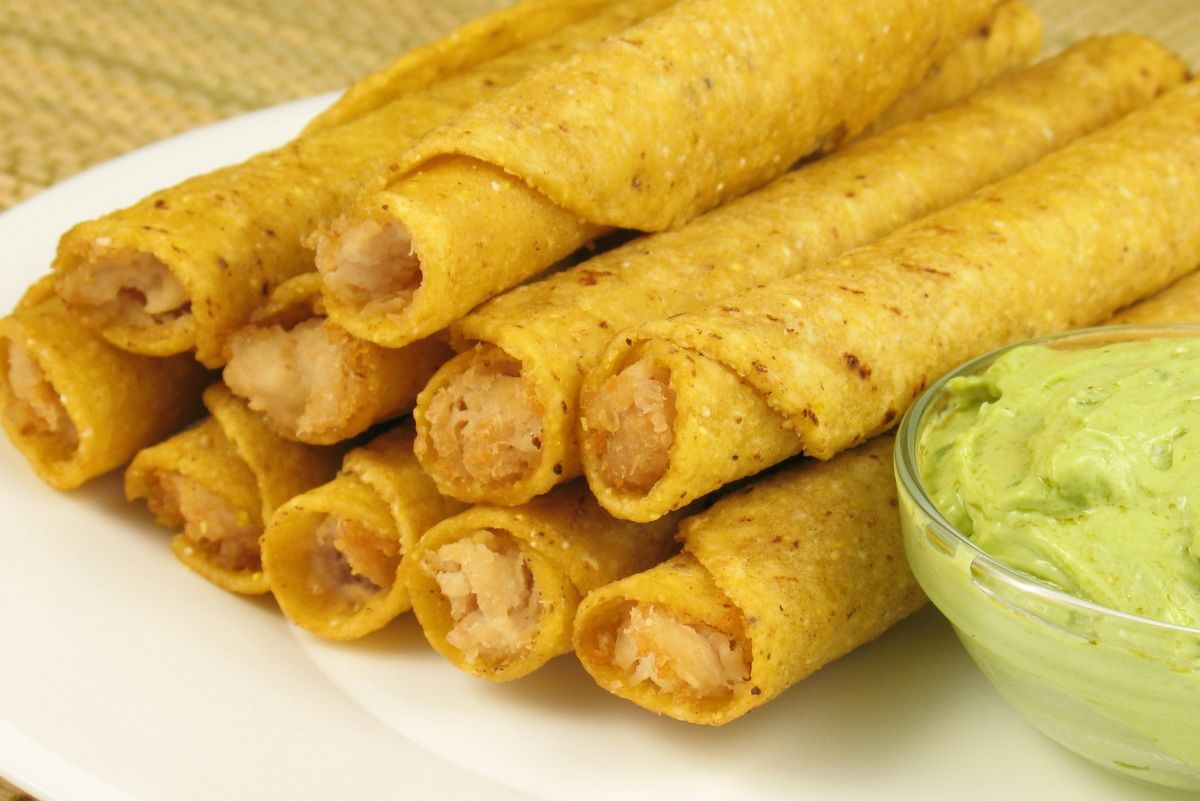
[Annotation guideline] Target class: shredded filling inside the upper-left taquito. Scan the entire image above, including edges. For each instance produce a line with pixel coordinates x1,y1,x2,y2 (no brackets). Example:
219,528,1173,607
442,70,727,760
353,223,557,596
58,252,191,327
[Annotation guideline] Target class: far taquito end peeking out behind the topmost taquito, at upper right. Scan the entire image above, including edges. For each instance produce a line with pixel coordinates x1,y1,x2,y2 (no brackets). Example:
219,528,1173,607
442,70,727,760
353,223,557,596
868,0,1042,133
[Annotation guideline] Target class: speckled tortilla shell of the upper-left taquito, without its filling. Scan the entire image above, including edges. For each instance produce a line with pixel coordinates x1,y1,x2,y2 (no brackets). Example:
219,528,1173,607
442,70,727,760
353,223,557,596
54,0,665,367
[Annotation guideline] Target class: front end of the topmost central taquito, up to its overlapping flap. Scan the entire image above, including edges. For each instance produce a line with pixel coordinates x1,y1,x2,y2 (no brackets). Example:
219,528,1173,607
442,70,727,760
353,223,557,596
314,157,604,348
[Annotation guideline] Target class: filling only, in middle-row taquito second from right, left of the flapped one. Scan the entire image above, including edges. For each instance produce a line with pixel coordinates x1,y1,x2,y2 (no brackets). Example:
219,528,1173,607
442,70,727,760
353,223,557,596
425,348,542,486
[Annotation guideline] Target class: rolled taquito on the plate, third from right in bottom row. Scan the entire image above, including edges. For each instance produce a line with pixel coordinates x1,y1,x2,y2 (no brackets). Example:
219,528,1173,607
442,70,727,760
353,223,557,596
262,422,464,640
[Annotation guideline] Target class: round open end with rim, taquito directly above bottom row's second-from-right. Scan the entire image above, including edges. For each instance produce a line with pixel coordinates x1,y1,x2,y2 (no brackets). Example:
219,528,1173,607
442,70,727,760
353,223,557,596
413,343,549,506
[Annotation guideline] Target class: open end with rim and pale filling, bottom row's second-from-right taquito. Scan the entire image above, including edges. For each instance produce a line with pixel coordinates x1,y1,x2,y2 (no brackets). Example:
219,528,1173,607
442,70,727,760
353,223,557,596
404,518,580,681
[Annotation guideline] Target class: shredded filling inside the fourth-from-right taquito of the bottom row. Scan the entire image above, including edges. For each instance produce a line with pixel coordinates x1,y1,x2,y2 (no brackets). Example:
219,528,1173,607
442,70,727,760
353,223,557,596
150,472,262,571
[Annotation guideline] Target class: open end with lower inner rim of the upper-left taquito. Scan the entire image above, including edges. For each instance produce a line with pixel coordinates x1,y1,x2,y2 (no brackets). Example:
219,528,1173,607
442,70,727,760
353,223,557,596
58,245,196,356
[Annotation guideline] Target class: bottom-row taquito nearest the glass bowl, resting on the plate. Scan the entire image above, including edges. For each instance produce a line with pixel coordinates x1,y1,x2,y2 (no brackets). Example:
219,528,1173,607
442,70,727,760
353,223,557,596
574,436,925,725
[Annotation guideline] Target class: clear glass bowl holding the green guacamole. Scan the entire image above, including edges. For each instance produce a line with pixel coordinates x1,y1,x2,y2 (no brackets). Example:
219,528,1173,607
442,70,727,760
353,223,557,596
895,325,1200,791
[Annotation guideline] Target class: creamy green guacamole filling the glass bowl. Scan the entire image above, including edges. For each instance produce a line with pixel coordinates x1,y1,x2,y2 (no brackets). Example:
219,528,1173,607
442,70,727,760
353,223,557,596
918,338,1200,627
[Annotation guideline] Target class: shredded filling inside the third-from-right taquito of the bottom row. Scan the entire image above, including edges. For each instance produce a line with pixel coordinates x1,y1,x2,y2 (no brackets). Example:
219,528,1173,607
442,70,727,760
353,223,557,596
310,514,401,604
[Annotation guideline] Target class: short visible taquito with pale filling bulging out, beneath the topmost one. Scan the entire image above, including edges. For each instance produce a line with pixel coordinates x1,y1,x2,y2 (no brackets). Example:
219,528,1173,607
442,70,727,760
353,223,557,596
222,272,452,445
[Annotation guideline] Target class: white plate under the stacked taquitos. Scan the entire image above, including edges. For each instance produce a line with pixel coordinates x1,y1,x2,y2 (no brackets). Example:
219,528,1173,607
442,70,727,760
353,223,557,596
0,98,1190,801
